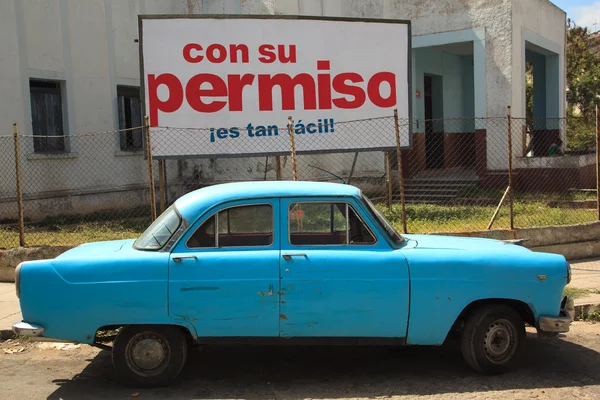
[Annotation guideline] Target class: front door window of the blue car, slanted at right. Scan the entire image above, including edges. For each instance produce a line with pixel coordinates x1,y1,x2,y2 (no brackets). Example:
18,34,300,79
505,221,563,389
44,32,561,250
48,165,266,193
288,202,376,246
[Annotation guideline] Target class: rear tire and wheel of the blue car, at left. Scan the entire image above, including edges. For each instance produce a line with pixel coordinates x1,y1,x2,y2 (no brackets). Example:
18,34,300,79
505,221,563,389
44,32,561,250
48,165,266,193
112,325,187,387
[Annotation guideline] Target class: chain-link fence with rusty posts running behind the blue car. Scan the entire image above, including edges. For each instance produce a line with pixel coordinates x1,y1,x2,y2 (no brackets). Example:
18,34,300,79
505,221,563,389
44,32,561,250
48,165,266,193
0,111,600,269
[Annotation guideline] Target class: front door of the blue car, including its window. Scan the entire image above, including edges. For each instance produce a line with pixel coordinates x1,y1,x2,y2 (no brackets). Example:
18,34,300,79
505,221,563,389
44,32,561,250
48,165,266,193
280,198,409,338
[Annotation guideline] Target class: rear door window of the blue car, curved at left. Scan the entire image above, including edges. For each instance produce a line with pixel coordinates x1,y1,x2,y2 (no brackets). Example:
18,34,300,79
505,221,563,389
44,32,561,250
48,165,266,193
187,204,273,248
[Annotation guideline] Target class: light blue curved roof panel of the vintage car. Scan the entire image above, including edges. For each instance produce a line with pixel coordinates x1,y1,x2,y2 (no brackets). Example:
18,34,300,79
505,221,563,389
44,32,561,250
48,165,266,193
175,181,360,223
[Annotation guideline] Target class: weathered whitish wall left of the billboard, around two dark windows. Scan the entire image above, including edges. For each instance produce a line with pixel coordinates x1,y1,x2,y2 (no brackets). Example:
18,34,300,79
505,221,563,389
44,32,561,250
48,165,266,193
0,0,193,203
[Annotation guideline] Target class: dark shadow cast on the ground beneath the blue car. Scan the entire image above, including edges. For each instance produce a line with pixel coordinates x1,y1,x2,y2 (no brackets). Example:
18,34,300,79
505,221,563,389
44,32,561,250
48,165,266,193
49,335,600,399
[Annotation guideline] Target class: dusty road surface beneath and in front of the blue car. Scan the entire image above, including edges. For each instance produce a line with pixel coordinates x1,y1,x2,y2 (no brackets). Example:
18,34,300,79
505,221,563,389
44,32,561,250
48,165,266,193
0,322,600,400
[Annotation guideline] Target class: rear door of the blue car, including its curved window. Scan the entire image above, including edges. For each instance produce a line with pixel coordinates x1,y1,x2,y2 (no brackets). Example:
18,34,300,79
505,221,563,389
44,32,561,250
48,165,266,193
169,199,280,337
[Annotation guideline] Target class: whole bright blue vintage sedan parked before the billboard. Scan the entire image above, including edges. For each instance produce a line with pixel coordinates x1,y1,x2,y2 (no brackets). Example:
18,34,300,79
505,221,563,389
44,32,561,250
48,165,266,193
13,181,573,386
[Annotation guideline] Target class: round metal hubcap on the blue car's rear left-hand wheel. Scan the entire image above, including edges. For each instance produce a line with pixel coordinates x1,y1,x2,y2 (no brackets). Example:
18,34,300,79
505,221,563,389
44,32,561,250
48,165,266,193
127,332,171,376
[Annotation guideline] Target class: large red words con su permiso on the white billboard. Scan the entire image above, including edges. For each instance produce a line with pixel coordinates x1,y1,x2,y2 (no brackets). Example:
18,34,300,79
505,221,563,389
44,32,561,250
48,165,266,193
147,43,397,126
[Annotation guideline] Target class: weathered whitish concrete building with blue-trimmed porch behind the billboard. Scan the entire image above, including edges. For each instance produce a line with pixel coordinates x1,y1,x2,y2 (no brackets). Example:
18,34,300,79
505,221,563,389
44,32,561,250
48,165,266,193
0,0,585,219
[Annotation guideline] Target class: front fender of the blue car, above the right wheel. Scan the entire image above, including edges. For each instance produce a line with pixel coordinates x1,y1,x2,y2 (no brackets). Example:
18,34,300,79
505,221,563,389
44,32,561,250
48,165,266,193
405,248,568,345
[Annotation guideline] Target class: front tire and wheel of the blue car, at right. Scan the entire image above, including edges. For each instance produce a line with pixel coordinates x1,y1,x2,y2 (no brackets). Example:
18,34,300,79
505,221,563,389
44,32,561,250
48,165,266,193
461,305,525,375
